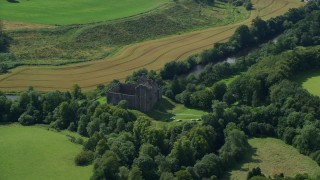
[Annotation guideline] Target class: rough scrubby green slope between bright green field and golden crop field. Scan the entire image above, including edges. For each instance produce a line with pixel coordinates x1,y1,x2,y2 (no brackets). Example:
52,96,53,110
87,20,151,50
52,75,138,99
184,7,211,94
5,1,250,66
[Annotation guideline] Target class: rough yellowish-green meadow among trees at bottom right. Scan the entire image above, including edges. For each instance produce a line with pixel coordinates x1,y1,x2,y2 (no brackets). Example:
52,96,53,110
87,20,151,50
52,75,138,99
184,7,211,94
224,138,320,179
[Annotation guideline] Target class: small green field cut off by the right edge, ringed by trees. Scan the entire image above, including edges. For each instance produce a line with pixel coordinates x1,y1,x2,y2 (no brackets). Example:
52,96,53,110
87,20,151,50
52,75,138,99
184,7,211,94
294,70,320,96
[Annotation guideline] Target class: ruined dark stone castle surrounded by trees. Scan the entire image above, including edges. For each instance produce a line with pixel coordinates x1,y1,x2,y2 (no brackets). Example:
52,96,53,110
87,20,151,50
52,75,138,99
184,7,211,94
107,75,162,112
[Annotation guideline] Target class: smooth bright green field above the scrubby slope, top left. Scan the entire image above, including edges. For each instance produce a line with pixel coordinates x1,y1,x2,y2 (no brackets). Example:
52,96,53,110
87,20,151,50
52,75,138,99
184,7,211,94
0,0,169,25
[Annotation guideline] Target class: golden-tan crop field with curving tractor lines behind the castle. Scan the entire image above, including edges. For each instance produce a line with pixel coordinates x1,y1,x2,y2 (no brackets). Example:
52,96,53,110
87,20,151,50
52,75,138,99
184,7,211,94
0,0,303,91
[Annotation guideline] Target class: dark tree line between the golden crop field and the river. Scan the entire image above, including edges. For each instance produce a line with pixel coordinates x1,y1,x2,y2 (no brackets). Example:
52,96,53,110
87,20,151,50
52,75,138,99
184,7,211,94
160,1,312,80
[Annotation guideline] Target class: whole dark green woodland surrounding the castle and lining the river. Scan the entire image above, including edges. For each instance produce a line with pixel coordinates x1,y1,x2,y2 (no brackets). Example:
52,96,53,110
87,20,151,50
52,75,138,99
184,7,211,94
0,0,320,180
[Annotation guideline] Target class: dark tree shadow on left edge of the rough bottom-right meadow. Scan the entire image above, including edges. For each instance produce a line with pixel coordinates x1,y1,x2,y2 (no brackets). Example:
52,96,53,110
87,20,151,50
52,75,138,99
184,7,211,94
222,147,261,180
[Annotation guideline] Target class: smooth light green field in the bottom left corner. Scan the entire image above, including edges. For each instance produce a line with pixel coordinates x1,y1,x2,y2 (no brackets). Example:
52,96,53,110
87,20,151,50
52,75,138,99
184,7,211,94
0,125,92,180
